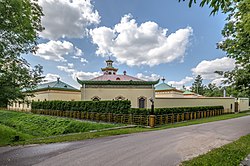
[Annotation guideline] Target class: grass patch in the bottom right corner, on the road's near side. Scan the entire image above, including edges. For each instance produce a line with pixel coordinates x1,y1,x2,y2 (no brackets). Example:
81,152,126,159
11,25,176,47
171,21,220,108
182,135,250,166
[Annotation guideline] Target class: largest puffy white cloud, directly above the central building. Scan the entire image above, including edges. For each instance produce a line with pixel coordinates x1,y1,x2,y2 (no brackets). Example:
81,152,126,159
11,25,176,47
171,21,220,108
90,14,193,66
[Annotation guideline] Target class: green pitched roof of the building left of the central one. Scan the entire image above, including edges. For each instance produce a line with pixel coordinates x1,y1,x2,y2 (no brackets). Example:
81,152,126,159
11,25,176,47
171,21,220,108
27,79,80,91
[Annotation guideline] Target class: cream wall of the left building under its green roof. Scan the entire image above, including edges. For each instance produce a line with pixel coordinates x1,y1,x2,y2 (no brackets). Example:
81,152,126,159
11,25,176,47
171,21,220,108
8,90,81,111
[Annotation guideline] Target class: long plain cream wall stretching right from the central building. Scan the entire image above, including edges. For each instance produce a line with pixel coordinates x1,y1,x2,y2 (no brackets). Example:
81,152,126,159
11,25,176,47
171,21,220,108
155,97,235,112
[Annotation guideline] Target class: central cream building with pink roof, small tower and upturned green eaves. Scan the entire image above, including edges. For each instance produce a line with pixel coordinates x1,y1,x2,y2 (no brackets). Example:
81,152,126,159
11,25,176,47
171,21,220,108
77,60,159,108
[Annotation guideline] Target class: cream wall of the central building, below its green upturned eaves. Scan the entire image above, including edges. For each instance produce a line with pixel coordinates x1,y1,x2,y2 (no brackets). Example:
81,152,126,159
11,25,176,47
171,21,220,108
81,86,154,108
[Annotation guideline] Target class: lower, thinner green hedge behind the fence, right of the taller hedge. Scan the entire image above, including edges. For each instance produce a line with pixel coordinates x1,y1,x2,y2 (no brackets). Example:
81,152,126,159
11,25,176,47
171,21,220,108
129,106,224,115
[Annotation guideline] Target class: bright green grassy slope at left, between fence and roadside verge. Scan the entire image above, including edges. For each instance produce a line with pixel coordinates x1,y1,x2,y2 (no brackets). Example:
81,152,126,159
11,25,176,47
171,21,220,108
0,110,121,145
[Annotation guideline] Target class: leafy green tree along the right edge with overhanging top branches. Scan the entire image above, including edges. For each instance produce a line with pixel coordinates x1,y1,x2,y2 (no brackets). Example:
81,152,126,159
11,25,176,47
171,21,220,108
179,0,250,97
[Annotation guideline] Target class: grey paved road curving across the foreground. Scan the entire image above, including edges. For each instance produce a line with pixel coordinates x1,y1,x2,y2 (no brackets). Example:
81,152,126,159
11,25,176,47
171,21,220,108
0,116,250,166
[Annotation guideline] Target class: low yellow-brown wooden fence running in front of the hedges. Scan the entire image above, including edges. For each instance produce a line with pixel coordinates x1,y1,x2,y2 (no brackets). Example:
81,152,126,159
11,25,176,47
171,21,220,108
31,110,224,126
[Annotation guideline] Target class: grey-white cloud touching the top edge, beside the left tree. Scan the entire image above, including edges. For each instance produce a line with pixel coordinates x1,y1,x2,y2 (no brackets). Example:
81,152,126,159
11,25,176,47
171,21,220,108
39,0,100,40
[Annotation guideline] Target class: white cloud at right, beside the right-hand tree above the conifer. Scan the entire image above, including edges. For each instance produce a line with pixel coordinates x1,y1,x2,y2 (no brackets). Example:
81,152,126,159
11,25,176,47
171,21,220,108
192,57,235,80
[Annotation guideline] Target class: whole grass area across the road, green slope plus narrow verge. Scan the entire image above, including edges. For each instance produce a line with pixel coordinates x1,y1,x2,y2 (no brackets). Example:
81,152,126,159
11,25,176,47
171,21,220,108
0,111,249,146
